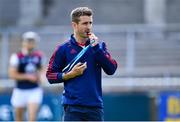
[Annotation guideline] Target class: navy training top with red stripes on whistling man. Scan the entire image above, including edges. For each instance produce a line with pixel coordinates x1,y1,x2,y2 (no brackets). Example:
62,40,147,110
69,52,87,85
46,35,117,108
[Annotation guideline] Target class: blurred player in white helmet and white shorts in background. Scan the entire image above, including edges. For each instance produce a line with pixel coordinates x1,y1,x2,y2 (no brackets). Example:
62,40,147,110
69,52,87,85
9,32,45,121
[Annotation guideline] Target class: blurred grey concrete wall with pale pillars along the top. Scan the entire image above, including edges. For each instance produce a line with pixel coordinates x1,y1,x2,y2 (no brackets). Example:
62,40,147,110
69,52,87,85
0,0,180,26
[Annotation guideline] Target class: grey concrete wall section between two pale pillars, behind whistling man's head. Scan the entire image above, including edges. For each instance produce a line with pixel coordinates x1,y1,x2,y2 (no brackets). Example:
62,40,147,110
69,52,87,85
45,0,144,25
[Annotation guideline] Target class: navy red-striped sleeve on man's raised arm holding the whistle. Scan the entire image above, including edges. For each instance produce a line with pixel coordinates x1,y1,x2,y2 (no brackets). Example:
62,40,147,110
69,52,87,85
93,42,117,75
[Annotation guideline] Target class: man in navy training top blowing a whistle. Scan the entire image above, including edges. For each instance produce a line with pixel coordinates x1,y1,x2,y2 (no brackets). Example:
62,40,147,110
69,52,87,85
46,7,117,121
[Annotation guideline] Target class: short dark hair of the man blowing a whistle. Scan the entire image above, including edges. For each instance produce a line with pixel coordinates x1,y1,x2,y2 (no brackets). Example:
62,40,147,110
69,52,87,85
71,7,93,23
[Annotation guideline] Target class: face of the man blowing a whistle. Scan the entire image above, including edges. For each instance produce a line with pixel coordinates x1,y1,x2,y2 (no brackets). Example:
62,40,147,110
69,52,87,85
73,16,93,38
